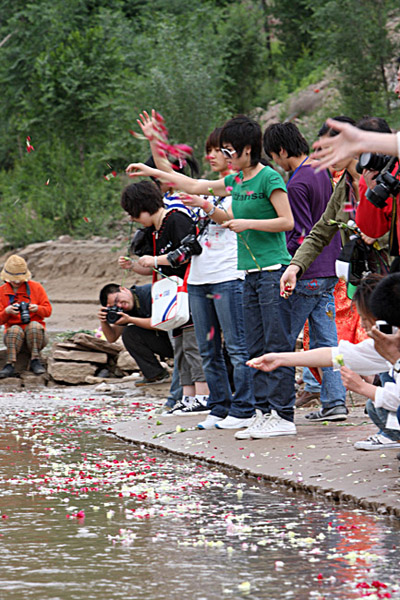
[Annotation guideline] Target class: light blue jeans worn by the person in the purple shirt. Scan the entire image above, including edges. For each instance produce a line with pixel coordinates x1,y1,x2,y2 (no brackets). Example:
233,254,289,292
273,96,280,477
292,277,346,408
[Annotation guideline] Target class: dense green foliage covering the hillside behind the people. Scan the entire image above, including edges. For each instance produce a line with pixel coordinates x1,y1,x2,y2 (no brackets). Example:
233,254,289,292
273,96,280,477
0,0,400,247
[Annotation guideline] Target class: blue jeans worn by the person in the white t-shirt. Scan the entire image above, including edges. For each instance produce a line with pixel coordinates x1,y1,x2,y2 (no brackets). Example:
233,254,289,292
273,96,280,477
188,279,254,418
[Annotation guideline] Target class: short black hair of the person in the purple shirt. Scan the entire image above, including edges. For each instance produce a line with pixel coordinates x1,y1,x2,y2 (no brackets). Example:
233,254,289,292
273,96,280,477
264,122,310,158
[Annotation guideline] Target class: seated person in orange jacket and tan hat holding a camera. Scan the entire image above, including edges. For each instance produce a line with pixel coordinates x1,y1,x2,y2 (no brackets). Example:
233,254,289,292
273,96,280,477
0,254,51,379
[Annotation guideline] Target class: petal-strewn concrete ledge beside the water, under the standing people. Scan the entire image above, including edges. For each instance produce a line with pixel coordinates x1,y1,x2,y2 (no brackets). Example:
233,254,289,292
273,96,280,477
106,407,400,517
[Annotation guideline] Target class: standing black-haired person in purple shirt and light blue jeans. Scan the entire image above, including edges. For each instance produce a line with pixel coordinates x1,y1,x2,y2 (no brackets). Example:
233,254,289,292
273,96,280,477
264,123,348,421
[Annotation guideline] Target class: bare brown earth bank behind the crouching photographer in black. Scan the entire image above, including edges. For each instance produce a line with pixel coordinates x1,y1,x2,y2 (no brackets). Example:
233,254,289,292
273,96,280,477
0,236,149,332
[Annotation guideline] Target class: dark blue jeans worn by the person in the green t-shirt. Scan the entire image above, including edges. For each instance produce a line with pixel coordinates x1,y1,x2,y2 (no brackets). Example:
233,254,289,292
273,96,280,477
244,267,295,421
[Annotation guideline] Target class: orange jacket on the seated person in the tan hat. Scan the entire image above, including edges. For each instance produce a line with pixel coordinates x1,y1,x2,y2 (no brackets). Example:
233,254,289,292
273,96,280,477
0,281,51,329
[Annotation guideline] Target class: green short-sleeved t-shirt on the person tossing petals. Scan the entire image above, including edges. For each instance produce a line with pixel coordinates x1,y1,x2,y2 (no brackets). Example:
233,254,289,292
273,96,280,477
225,167,292,270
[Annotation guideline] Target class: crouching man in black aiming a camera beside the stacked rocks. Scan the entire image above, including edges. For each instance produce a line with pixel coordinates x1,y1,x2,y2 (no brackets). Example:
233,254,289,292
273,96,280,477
98,283,174,386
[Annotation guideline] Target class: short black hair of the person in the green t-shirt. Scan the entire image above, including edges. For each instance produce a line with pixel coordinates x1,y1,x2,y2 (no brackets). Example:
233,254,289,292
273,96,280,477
220,115,262,167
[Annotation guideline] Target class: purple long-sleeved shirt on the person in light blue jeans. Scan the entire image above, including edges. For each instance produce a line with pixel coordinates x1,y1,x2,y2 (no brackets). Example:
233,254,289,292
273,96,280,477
286,165,341,279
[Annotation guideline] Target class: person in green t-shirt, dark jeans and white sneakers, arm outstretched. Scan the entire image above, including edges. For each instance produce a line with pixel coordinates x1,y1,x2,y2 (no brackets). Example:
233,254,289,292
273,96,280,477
127,116,296,439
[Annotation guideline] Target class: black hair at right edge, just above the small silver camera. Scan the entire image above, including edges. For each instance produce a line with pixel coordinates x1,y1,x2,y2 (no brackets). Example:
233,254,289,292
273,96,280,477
370,273,400,327
